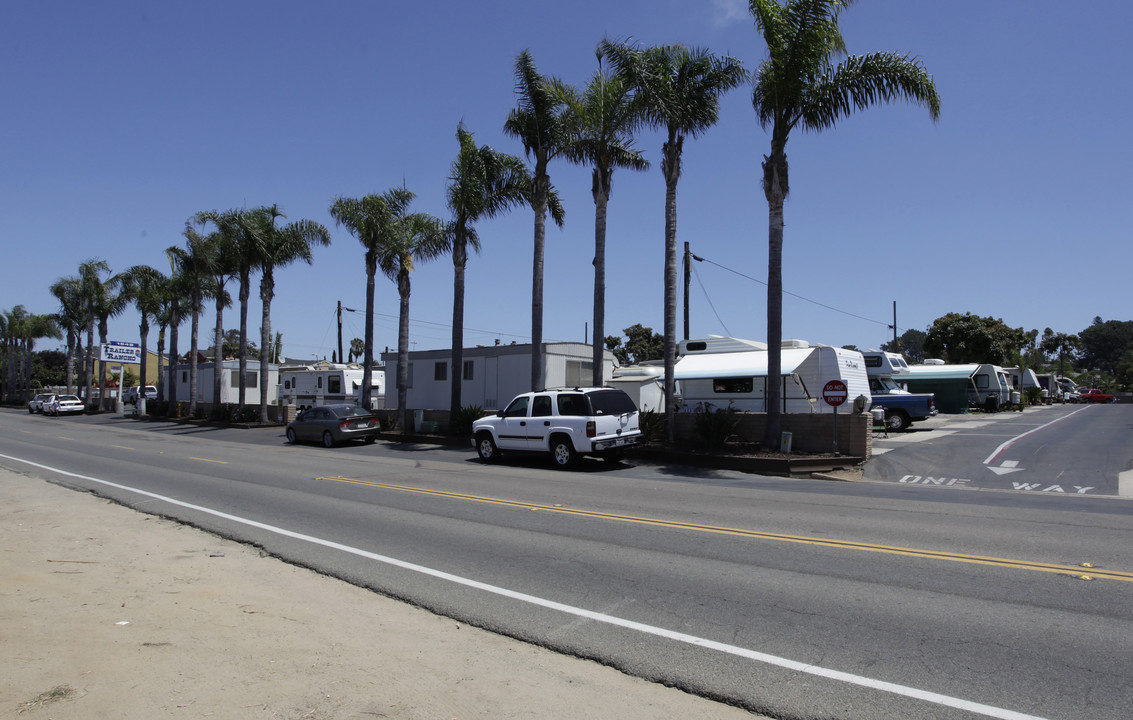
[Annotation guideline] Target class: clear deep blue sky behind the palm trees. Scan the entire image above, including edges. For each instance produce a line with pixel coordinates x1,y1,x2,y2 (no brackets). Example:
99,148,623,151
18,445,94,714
0,0,1133,359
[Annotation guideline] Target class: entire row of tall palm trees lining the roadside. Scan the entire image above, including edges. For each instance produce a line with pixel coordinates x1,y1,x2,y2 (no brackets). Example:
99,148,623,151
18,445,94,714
6,0,939,447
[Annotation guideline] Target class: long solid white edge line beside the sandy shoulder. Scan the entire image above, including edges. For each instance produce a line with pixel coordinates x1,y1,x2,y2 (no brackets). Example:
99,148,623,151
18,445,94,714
0,455,1043,720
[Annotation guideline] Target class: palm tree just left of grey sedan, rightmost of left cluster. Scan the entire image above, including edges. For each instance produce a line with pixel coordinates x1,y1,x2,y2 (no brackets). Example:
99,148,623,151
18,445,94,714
246,205,331,423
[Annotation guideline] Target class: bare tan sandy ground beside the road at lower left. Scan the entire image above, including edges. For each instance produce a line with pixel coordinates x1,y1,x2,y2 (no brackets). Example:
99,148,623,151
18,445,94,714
0,471,755,720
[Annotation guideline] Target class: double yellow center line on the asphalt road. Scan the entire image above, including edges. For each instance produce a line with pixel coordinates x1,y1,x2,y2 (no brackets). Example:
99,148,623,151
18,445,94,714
316,476,1133,583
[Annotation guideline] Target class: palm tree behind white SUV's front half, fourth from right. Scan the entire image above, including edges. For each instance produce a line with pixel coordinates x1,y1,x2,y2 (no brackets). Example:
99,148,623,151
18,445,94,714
505,50,571,390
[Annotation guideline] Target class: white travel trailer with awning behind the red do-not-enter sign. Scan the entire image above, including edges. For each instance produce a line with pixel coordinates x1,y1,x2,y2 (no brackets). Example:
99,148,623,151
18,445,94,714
674,337,870,413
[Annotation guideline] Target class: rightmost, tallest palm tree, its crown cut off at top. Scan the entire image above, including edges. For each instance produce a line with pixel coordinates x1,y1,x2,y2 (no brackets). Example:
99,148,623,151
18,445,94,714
749,0,940,447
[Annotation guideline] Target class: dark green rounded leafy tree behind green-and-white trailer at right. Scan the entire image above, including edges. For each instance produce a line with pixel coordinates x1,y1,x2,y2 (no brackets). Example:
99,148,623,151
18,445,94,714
925,313,1029,365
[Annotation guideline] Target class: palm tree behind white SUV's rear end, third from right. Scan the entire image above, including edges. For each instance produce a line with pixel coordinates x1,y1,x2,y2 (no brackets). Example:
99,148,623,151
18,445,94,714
555,56,649,387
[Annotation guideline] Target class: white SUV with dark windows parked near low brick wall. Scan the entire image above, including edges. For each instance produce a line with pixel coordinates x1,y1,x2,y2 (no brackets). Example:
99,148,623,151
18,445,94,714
472,388,642,468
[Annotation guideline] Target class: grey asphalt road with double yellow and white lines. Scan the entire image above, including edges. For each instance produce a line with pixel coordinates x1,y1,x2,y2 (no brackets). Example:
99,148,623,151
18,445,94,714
0,406,1133,720
